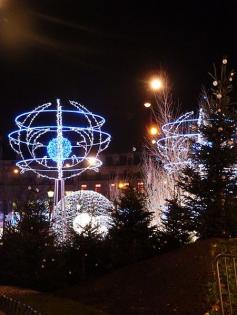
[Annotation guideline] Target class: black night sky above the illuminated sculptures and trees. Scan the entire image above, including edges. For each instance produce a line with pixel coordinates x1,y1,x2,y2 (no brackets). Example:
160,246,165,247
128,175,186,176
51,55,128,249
0,0,237,156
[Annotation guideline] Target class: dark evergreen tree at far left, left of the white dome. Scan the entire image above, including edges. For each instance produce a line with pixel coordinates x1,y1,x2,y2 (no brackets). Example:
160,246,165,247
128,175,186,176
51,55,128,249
0,191,57,289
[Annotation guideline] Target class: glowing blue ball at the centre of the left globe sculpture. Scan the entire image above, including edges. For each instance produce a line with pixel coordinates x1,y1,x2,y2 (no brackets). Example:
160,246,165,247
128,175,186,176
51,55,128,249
47,138,72,162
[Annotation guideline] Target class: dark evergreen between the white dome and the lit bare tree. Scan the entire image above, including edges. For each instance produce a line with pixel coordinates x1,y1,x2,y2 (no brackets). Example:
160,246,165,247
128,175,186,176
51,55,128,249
109,188,155,266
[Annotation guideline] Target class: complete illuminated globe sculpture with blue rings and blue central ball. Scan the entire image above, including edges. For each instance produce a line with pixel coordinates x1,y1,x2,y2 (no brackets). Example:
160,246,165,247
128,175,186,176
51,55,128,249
8,99,111,239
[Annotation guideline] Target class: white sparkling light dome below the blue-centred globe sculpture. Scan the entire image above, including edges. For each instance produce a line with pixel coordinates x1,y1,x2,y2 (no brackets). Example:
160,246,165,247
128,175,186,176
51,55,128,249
53,190,113,242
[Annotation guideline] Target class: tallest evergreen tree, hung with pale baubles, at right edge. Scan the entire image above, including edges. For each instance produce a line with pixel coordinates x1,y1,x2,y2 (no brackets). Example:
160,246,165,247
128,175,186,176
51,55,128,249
179,59,237,238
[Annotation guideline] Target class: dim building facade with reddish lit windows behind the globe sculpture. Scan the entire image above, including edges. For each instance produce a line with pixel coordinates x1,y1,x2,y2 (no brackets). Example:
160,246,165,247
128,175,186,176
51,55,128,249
0,152,143,221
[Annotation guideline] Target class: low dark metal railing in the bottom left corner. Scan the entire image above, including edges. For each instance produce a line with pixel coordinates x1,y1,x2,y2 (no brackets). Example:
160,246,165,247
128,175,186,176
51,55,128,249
0,295,42,315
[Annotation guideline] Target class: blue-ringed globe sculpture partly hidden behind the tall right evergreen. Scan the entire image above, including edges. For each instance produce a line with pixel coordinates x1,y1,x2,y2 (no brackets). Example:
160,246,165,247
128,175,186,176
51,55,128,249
157,111,200,173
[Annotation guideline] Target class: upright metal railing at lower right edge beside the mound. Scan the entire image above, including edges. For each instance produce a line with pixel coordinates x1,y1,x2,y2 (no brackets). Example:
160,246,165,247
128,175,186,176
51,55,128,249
215,254,237,315
